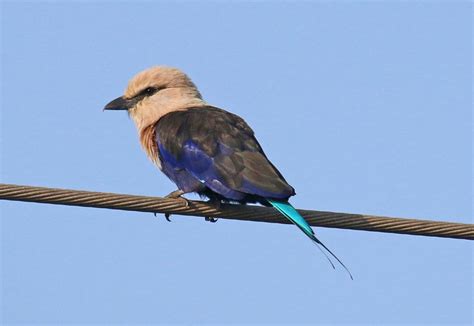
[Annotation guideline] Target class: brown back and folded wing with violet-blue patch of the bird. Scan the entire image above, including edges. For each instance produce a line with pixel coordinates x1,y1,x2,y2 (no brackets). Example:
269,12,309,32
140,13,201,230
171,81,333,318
155,106,294,202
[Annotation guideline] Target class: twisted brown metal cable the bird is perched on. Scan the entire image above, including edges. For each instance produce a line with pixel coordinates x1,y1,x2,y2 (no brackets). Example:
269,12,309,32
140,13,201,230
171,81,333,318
0,184,474,240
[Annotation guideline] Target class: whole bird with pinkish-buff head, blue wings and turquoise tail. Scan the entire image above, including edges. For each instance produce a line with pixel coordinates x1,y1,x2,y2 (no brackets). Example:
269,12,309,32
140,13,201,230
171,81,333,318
104,66,352,278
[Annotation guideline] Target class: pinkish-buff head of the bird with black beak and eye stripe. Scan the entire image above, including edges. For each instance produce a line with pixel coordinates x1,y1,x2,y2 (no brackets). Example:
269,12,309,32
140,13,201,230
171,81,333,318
104,66,206,130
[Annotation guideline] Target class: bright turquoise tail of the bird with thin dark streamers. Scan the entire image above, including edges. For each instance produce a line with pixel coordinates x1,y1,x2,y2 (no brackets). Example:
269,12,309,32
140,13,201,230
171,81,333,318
267,199,353,279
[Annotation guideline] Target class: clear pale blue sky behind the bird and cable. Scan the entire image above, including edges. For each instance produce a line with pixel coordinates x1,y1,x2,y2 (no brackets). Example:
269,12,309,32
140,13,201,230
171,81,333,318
0,1,473,324
